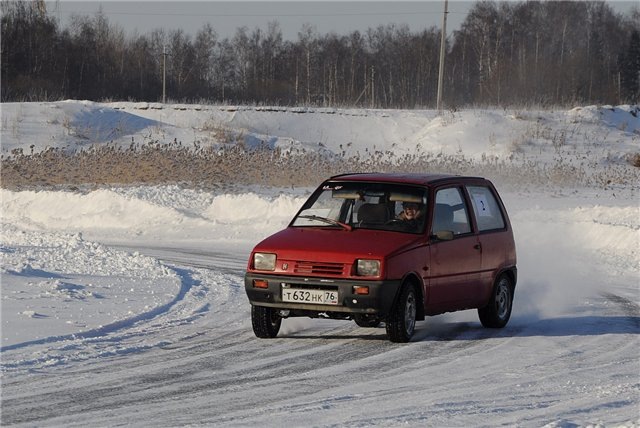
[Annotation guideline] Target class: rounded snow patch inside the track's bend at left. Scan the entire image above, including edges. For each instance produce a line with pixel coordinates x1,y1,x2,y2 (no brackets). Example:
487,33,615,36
0,223,182,350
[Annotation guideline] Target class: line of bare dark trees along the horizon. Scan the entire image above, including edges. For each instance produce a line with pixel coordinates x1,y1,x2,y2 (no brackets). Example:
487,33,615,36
1,0,640,108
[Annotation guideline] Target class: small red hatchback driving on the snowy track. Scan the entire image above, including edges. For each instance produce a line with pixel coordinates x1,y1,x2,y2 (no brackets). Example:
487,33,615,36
245,173,517,342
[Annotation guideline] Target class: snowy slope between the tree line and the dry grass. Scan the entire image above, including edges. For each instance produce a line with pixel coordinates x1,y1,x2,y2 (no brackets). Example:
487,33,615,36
0,101,640,168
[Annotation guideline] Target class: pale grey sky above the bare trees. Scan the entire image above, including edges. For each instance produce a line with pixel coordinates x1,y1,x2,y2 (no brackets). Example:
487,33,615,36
47,0,637,40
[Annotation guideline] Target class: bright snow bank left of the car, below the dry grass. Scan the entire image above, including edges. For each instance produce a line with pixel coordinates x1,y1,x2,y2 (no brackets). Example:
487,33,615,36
0,186,305,240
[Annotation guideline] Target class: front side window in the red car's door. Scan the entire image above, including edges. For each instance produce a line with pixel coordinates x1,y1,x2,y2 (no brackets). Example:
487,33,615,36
432,187,471,235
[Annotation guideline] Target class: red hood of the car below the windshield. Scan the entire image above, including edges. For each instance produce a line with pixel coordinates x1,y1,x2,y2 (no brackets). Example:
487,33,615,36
254,227,421,263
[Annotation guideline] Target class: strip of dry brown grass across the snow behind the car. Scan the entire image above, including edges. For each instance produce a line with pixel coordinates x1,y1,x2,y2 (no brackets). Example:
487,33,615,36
0,142,640,190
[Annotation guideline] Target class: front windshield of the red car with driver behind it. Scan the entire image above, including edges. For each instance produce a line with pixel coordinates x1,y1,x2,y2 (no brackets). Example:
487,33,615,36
290,182,427,233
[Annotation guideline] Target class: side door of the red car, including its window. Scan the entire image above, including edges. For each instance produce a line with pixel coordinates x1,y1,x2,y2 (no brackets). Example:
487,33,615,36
426,187,482,314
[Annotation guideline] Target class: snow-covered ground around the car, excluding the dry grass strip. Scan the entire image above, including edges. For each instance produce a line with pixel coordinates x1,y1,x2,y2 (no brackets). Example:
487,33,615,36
0,101,640,428
